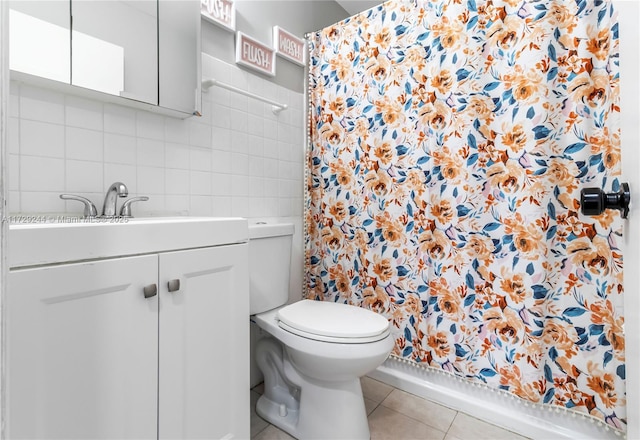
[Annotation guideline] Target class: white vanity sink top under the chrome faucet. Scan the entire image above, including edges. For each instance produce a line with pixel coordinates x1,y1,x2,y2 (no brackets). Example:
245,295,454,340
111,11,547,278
9,217,249,268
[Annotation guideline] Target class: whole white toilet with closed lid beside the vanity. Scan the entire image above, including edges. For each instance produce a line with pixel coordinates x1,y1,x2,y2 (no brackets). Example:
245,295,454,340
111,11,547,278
249,224,393,440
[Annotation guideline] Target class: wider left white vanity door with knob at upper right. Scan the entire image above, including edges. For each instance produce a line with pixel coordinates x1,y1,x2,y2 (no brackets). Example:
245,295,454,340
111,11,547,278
6,255,158,439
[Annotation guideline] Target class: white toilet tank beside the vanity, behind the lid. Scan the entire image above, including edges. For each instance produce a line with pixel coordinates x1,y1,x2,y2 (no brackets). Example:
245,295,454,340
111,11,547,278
249,223,294,315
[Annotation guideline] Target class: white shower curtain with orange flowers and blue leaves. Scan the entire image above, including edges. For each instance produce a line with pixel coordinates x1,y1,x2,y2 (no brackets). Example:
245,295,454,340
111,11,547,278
305,0,626,431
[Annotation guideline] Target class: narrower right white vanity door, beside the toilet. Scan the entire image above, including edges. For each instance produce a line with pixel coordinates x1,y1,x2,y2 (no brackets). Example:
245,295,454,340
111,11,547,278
158,244,250,439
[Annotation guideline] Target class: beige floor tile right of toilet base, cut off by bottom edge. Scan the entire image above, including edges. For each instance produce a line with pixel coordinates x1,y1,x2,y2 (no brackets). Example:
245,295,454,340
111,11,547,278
369,405,445,440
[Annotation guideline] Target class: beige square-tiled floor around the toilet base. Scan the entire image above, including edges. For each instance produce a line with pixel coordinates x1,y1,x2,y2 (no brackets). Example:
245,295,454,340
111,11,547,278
251,377,527,440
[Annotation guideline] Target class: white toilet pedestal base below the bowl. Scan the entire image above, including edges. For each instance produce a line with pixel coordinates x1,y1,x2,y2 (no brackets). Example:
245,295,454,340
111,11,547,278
256,338,370,440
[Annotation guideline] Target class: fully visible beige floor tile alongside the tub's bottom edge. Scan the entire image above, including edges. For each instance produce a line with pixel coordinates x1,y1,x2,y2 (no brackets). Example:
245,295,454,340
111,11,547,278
381,390,457,432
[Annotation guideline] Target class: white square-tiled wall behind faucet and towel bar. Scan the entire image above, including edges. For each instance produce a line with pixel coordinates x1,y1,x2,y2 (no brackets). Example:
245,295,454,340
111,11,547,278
8,55,306,218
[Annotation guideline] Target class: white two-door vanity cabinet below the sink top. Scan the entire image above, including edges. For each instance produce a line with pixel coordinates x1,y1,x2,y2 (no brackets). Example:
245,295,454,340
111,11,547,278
6,218,250,440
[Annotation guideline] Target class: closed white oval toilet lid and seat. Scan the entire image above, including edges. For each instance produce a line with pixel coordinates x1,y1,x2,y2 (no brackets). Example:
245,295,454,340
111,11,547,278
278,299,389,343
